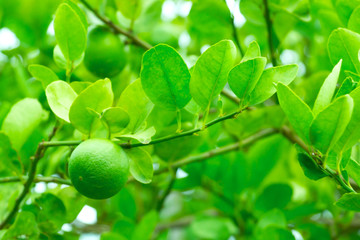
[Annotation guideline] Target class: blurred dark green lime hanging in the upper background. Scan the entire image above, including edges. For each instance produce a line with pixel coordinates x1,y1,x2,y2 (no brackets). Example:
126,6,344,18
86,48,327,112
84,26,126,78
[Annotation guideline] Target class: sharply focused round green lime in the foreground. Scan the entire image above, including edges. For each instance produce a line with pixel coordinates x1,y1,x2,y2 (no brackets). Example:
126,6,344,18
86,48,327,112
69,139,129,199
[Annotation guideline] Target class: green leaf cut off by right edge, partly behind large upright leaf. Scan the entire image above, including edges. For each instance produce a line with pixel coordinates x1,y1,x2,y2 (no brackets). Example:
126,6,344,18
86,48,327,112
335,87,360,151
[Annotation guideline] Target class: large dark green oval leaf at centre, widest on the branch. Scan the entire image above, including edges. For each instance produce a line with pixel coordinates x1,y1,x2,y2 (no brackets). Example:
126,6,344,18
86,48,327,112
140,44,191,110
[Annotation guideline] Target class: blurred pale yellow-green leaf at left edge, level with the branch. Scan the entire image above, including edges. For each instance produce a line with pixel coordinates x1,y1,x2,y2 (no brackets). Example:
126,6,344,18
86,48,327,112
1,98,48,150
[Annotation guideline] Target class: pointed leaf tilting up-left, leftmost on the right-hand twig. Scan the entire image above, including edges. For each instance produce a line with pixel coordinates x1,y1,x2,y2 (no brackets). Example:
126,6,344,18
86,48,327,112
277,83,314,142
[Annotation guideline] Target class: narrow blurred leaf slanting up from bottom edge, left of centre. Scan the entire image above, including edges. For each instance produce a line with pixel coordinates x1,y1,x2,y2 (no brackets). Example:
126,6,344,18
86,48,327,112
131,210,159,240
